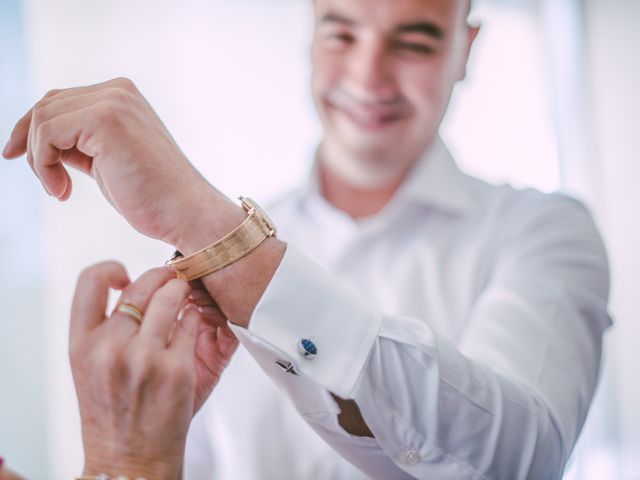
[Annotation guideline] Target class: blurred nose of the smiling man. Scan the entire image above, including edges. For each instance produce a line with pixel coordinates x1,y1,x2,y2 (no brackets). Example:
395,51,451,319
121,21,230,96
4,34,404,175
348,41,396,103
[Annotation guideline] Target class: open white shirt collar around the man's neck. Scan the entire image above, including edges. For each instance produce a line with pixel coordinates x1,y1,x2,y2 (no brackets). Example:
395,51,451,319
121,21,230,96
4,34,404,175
302,136,473,220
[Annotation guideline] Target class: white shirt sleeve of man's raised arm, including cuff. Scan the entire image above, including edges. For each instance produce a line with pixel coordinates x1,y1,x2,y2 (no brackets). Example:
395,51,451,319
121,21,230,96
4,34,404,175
231,196,610,480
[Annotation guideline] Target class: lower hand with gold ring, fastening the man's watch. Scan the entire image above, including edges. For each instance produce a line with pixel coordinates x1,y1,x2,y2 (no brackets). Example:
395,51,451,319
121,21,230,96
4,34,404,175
70,262,230,479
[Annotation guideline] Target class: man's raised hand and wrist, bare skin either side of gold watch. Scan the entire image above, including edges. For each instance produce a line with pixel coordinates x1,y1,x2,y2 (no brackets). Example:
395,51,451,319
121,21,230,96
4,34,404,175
3,78,285,330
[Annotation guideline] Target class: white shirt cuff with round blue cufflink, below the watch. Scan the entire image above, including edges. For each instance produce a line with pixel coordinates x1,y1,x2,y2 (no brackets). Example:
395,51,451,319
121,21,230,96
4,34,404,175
230,245,382,398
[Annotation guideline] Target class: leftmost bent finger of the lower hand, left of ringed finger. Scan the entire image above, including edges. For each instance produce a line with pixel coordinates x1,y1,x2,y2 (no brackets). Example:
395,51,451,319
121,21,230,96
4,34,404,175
71,262,129,343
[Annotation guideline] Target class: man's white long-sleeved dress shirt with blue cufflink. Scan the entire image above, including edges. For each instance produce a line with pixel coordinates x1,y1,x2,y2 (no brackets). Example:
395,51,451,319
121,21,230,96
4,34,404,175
185,137,610,480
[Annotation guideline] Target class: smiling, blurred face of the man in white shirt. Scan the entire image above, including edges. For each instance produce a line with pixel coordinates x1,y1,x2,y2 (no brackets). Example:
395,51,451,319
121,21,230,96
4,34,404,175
312,0,476,175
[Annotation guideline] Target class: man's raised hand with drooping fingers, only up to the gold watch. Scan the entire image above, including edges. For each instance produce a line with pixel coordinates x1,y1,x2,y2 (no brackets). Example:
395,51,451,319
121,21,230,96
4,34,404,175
3,78,219,245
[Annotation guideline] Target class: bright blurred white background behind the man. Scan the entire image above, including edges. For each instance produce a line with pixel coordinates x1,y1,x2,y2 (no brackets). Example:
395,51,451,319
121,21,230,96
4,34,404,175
0,0,640,479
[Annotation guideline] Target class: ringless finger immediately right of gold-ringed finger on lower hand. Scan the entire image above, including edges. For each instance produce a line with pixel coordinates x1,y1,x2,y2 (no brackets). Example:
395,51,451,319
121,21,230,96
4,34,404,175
140,279,189,346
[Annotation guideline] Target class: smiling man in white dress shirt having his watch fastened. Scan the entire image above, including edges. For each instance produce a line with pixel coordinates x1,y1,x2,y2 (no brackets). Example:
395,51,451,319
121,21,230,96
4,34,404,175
5,0,609,479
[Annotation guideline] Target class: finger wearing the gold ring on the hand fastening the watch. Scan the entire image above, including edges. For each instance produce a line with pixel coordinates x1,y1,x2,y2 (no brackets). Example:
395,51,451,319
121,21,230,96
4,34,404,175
107,267,175,338
